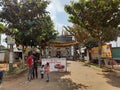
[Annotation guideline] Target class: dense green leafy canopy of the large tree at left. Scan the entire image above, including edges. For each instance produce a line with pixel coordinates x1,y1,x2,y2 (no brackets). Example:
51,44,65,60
0,0,57,46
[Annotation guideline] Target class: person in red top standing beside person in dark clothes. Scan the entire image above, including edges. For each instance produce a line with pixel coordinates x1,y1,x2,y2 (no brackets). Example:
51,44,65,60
26,55,34,81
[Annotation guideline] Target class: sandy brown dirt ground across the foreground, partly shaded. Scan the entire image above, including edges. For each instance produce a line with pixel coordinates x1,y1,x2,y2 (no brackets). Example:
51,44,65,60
0,61,120,90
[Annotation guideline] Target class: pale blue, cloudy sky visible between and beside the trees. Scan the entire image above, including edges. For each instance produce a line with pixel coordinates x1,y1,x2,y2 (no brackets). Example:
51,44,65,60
2,0,120,47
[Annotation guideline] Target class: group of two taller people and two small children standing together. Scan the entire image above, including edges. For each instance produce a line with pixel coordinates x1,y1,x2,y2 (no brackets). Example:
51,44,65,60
26,50,50,82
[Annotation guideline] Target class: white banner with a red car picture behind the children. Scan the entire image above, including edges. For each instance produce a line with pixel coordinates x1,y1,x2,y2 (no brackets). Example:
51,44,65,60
42,58,67,72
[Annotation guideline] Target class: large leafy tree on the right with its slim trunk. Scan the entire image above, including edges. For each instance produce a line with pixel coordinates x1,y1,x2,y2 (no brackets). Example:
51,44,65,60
65,0,120,65
